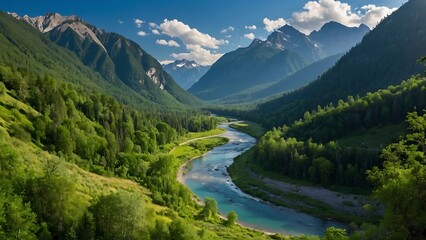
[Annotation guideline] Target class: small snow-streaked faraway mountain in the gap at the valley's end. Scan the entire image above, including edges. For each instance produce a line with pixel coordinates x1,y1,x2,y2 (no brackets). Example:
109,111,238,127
163,59,210,90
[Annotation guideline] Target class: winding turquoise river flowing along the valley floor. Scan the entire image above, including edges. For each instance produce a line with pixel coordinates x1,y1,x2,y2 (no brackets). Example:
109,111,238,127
184,124,347,236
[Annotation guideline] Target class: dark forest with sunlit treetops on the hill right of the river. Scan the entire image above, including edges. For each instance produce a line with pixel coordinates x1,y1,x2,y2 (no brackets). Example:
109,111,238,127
253,76,426,187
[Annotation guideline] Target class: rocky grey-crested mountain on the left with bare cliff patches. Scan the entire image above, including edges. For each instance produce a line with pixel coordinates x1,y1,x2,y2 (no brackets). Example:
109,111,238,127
15,13,198,105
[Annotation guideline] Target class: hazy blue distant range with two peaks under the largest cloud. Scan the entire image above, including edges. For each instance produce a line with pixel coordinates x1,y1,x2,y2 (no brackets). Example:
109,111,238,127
189,22,369,102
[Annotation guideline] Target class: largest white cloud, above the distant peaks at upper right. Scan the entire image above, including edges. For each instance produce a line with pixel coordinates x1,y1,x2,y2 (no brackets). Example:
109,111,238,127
289,0,396,34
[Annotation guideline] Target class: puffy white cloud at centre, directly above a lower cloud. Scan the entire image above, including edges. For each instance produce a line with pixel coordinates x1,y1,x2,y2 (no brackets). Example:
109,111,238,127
158,19,226,49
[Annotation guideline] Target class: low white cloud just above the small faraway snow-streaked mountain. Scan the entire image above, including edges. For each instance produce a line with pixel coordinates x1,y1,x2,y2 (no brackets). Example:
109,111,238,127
171,45,223,66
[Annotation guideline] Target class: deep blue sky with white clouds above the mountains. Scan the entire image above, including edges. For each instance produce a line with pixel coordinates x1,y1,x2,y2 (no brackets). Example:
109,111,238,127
0,0,407,65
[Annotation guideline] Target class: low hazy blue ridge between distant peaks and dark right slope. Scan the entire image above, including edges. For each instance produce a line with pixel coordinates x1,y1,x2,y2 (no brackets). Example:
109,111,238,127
222,54,343,103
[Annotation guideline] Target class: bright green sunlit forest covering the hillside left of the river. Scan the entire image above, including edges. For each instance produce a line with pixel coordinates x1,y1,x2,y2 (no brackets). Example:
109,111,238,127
0,66,230,239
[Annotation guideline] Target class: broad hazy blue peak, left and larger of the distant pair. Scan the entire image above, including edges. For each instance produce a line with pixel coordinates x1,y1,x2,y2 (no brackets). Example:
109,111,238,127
188,26,325,100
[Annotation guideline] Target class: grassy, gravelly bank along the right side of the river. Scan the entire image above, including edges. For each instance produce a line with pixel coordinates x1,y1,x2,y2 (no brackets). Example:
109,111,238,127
228,151,374,224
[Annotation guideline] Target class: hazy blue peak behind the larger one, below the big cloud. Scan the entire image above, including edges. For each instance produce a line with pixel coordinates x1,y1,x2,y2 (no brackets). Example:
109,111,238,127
309,21,370,56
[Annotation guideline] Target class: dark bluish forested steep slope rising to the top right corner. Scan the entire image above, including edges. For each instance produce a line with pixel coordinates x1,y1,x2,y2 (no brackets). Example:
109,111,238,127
252,0,426,126
